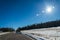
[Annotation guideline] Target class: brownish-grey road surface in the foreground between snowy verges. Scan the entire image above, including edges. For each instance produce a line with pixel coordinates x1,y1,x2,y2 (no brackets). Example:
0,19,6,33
0,33,32,40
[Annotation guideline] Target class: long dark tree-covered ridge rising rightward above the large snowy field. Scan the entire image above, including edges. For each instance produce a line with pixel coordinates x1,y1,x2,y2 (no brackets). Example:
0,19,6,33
17,20,60,30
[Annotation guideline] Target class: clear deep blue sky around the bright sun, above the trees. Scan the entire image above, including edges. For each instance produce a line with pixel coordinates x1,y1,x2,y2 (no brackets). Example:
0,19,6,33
0,0,60,28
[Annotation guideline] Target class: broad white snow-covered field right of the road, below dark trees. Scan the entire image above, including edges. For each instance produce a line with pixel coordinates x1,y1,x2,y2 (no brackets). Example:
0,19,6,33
21,27,60,40
